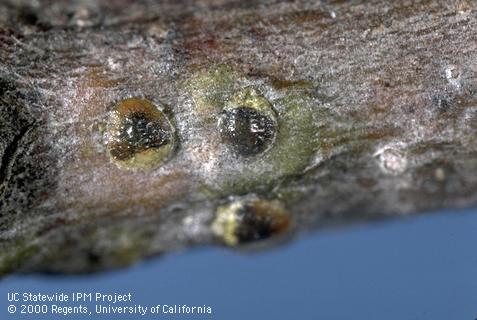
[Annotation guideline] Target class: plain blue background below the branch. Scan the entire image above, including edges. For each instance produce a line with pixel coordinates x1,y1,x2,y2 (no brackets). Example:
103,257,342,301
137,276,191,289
0,209,477,320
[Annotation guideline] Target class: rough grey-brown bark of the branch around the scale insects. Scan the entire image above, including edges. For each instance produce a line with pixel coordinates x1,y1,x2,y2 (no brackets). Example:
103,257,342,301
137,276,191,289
0,0,477,274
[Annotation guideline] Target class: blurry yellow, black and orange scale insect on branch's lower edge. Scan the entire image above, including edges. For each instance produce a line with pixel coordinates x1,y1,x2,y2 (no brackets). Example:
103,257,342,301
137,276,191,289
212,198,291,246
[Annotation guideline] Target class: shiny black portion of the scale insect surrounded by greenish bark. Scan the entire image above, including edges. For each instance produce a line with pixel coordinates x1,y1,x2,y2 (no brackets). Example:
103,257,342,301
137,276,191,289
219,106,276,156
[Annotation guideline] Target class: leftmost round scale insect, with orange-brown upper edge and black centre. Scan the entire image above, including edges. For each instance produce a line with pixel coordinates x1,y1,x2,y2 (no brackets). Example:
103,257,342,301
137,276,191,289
107,98,177,169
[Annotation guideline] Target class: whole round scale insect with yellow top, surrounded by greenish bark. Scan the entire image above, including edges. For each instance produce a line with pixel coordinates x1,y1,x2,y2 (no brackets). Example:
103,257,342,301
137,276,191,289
218,88,277,156
